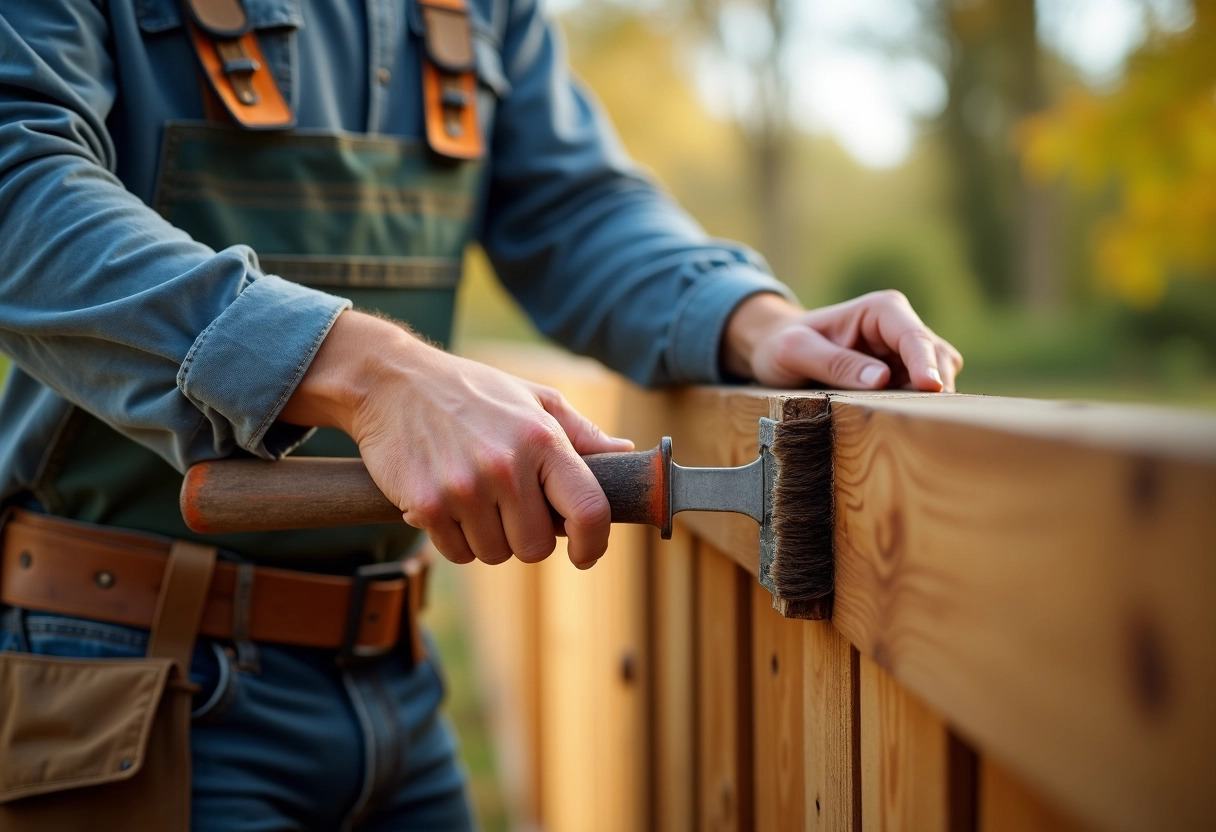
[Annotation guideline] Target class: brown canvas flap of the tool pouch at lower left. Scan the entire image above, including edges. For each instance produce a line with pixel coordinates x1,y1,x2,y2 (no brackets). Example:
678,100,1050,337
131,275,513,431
0,653,173,803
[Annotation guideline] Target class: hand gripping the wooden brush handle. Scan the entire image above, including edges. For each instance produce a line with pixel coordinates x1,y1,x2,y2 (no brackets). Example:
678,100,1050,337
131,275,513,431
280,311,634,568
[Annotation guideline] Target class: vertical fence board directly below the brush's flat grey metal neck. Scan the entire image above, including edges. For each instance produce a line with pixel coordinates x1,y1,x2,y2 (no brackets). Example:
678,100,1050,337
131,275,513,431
697,541,755,832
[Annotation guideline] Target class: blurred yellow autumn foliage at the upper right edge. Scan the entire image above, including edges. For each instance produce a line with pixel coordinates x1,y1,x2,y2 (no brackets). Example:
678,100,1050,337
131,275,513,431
1020,0,1216,307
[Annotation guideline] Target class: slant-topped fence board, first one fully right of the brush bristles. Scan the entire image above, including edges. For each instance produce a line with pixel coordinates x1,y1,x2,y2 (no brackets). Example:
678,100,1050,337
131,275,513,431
860,656,950,832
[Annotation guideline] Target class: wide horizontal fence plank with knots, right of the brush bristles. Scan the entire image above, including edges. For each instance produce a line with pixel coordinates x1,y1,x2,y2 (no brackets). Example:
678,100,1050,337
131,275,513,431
832,397,1216,832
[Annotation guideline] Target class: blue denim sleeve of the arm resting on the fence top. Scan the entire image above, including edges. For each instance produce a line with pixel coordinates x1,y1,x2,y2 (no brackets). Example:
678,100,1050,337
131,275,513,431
482,0,793,386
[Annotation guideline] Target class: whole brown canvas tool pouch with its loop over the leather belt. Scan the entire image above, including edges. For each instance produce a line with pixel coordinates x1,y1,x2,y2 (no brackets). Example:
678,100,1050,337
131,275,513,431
0,541,215,832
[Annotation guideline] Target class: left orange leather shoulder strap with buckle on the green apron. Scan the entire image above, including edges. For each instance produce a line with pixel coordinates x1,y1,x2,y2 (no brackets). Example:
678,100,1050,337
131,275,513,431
182,0,295,130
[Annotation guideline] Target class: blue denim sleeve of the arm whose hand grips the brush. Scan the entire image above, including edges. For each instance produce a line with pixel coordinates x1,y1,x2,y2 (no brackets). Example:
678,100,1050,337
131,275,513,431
0,0,349,470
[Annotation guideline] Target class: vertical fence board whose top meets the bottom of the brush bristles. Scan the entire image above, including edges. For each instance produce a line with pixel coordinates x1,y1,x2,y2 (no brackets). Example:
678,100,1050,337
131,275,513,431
801,622,861,832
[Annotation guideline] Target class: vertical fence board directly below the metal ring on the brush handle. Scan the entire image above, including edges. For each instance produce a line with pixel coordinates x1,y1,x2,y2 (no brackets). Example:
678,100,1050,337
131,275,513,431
649,527,697,830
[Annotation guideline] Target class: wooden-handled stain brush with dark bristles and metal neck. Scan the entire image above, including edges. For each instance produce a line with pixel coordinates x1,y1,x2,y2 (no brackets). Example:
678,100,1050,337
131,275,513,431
181,411,834,618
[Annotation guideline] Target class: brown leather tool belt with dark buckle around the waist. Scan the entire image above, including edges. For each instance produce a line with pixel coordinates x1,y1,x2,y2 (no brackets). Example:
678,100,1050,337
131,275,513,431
0,510,427,663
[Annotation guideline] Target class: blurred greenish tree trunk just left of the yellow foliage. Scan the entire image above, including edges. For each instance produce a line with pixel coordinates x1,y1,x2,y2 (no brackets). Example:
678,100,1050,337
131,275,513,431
921,0,1059,309
